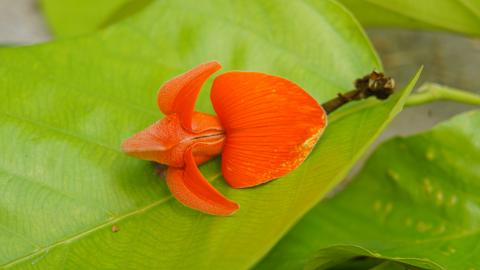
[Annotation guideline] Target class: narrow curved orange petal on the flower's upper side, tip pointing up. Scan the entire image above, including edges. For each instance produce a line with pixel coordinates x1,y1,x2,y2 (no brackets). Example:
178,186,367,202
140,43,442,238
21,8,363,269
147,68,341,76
157,62,221,132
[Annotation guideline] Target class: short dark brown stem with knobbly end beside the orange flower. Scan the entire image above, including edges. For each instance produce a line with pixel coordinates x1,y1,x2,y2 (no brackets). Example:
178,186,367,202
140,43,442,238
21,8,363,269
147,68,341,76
322,71,395,114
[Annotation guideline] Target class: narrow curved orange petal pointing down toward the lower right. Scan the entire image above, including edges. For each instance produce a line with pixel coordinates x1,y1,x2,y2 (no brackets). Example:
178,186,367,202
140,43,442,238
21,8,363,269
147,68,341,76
167,148,239,216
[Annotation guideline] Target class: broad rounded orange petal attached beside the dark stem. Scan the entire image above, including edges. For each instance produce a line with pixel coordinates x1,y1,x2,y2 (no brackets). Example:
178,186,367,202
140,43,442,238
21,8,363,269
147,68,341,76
211,72,327,188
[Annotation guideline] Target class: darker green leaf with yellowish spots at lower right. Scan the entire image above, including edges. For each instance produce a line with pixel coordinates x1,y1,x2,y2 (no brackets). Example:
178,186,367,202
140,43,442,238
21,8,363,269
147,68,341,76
257,111,480,269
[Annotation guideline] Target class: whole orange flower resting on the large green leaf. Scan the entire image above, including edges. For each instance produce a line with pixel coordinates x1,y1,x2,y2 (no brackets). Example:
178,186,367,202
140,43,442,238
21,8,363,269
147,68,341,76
123,62,327,215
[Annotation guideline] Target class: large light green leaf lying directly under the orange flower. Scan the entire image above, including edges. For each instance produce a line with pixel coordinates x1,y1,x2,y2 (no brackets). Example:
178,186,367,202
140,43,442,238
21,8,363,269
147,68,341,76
0,0,418,269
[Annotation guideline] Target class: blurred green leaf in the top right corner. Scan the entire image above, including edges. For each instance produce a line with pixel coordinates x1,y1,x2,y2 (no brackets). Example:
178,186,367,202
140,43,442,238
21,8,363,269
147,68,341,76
340,0,480,36
